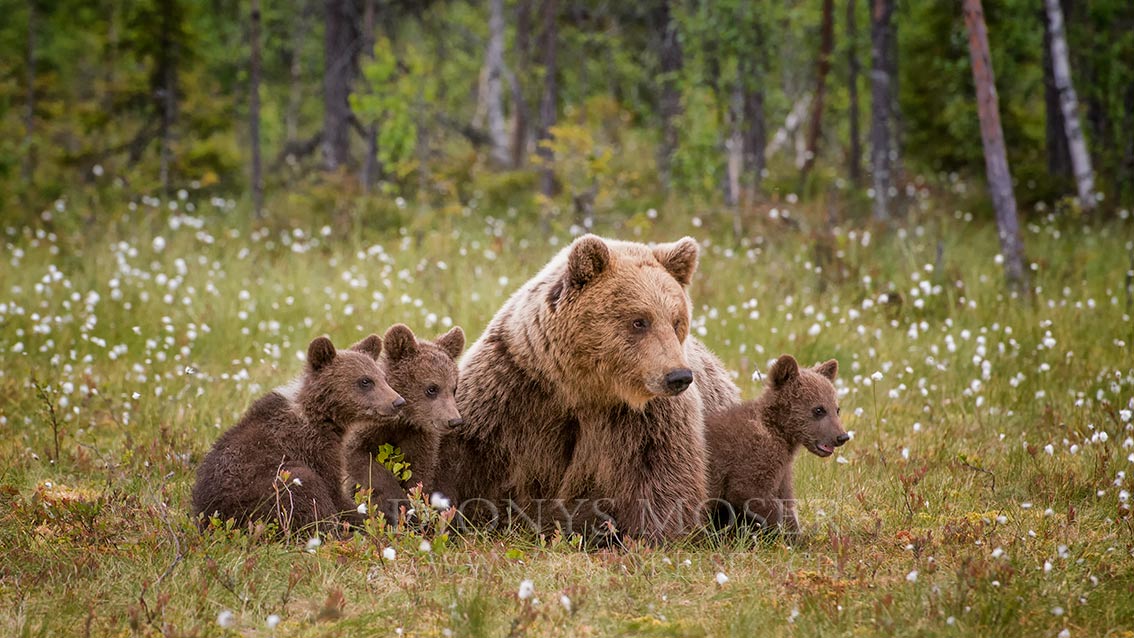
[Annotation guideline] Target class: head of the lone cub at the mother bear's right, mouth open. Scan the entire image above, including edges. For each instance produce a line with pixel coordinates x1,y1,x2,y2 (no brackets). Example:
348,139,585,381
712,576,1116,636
765,355,851,457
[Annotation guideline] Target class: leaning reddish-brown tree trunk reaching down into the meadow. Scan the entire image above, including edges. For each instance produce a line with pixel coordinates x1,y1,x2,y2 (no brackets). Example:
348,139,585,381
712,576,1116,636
964,0,1027,289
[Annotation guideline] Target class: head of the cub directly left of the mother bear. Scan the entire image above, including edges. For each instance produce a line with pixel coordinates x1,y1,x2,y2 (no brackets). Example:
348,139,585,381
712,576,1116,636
382,323,465,429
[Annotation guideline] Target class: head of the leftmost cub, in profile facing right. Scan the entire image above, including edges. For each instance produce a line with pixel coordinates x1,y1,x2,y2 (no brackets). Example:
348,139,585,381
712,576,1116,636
298,334,406,431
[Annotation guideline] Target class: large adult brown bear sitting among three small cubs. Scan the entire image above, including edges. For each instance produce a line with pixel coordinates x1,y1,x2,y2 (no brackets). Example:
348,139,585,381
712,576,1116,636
428,235,739,541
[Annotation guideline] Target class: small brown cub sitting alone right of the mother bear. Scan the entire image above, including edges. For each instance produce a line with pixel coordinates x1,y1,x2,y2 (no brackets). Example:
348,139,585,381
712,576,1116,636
705,355,851,534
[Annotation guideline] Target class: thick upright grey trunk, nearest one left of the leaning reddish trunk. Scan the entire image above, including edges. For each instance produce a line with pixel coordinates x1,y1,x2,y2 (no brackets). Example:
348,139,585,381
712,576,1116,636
870,0,894,221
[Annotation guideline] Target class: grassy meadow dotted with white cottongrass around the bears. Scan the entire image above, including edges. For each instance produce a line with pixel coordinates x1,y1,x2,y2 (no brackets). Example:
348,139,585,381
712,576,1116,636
0,197,1134,636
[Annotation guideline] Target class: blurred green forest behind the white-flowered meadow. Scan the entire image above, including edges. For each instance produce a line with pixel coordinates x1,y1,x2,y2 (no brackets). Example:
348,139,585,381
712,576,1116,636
0,0,1134,233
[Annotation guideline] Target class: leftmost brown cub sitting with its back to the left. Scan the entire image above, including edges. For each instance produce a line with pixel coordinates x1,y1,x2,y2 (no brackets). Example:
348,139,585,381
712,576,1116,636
193,334,406,535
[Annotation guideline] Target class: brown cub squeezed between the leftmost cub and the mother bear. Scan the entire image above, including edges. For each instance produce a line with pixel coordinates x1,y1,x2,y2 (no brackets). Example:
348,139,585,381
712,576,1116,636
342,323,465,524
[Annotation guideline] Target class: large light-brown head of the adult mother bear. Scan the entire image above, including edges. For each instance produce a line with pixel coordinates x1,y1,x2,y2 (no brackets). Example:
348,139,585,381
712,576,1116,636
545,235,697,410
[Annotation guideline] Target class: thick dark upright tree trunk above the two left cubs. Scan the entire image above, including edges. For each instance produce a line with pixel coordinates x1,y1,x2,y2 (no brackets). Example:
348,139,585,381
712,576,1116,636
322,0,358,171
